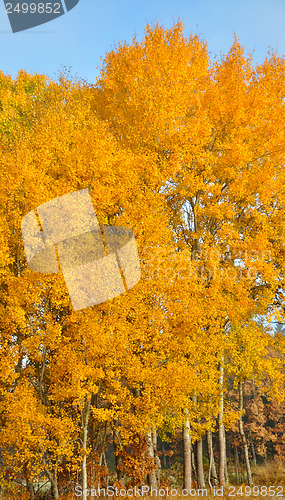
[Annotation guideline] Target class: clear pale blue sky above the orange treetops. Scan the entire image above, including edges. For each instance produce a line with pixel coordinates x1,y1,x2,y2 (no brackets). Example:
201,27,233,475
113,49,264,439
0,0,285,83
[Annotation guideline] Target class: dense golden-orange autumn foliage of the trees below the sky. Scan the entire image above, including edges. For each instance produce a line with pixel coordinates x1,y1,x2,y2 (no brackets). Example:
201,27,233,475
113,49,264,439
0,19,285,498
